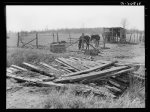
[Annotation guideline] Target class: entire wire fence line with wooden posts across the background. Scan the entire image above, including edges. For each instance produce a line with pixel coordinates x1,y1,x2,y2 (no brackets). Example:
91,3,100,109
7,33,145,48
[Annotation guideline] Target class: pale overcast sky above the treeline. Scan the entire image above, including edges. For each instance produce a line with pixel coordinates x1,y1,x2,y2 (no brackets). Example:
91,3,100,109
6,5,144,31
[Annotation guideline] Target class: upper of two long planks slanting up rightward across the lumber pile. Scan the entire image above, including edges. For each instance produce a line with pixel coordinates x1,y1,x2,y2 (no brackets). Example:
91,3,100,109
61,61,117,77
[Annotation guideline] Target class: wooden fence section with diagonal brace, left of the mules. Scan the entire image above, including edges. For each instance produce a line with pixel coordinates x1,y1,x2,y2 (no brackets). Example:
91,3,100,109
17,32,78,48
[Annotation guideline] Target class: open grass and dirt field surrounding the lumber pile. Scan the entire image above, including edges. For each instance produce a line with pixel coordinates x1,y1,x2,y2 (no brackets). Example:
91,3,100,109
6,35,145,109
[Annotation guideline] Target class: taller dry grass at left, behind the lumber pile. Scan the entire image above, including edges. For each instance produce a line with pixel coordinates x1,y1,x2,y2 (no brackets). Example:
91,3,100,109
7,48,54,66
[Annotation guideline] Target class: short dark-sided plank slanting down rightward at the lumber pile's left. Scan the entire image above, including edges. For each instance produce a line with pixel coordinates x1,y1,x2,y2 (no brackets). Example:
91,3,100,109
23,62,54,77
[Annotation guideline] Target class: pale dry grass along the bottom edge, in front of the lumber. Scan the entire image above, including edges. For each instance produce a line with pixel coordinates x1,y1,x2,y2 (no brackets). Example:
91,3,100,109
44,81,145,109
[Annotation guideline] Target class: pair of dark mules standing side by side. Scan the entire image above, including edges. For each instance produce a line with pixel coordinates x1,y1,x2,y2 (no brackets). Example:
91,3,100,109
78,34,100,50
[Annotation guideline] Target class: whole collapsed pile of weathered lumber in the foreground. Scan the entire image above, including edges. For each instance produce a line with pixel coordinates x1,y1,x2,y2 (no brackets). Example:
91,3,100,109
7,57,144,96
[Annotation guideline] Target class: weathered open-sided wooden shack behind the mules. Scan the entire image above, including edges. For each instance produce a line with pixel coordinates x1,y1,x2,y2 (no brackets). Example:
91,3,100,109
103,27,126,43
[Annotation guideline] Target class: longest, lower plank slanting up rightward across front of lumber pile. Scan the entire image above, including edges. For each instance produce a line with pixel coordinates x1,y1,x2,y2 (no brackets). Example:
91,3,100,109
54,66,128,83
